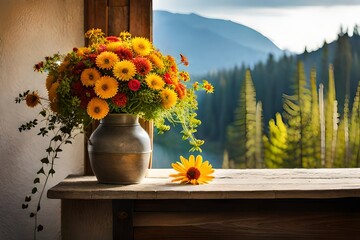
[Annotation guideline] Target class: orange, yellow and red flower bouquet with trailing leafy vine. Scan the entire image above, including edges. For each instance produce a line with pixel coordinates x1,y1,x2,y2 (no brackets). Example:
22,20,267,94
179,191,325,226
15,29,213,236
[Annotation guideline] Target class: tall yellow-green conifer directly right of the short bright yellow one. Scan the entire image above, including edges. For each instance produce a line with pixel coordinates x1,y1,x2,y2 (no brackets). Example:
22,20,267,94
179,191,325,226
283,61,315,167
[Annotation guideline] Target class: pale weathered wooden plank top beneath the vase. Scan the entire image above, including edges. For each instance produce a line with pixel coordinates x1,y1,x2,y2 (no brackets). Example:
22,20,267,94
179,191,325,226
47,168,360,200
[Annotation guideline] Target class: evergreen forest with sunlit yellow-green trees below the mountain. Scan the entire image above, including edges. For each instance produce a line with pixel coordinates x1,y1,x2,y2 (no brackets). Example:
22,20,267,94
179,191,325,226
197,26,360,168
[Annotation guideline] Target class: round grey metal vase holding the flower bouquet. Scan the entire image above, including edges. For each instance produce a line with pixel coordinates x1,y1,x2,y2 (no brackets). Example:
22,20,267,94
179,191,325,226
88,114,152,184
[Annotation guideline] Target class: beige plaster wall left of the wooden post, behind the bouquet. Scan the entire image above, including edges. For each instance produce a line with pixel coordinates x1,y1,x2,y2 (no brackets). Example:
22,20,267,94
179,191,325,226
0,0,84,240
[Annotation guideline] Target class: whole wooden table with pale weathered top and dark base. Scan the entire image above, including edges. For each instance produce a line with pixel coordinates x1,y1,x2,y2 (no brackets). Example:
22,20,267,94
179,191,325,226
48,169,360,240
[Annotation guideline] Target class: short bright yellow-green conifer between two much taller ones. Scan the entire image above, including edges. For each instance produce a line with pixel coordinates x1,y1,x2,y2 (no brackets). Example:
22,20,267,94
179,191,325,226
263,113,288,168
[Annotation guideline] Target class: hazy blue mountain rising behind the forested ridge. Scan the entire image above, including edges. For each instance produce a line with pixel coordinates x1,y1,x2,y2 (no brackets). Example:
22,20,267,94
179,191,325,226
153,11,283,74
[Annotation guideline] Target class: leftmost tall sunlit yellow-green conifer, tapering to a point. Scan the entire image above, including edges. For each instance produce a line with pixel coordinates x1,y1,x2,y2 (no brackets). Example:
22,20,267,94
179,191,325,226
227,69,257,168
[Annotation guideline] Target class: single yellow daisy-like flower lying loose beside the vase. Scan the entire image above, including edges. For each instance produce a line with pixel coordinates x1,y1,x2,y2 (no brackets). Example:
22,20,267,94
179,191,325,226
170,155,214,185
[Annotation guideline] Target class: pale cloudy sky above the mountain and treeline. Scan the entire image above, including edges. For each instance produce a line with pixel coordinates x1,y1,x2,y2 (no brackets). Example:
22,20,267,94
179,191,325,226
153,0,360,53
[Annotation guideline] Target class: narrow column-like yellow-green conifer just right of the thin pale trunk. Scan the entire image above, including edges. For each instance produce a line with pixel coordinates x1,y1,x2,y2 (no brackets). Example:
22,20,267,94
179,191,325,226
325,65,337,168
